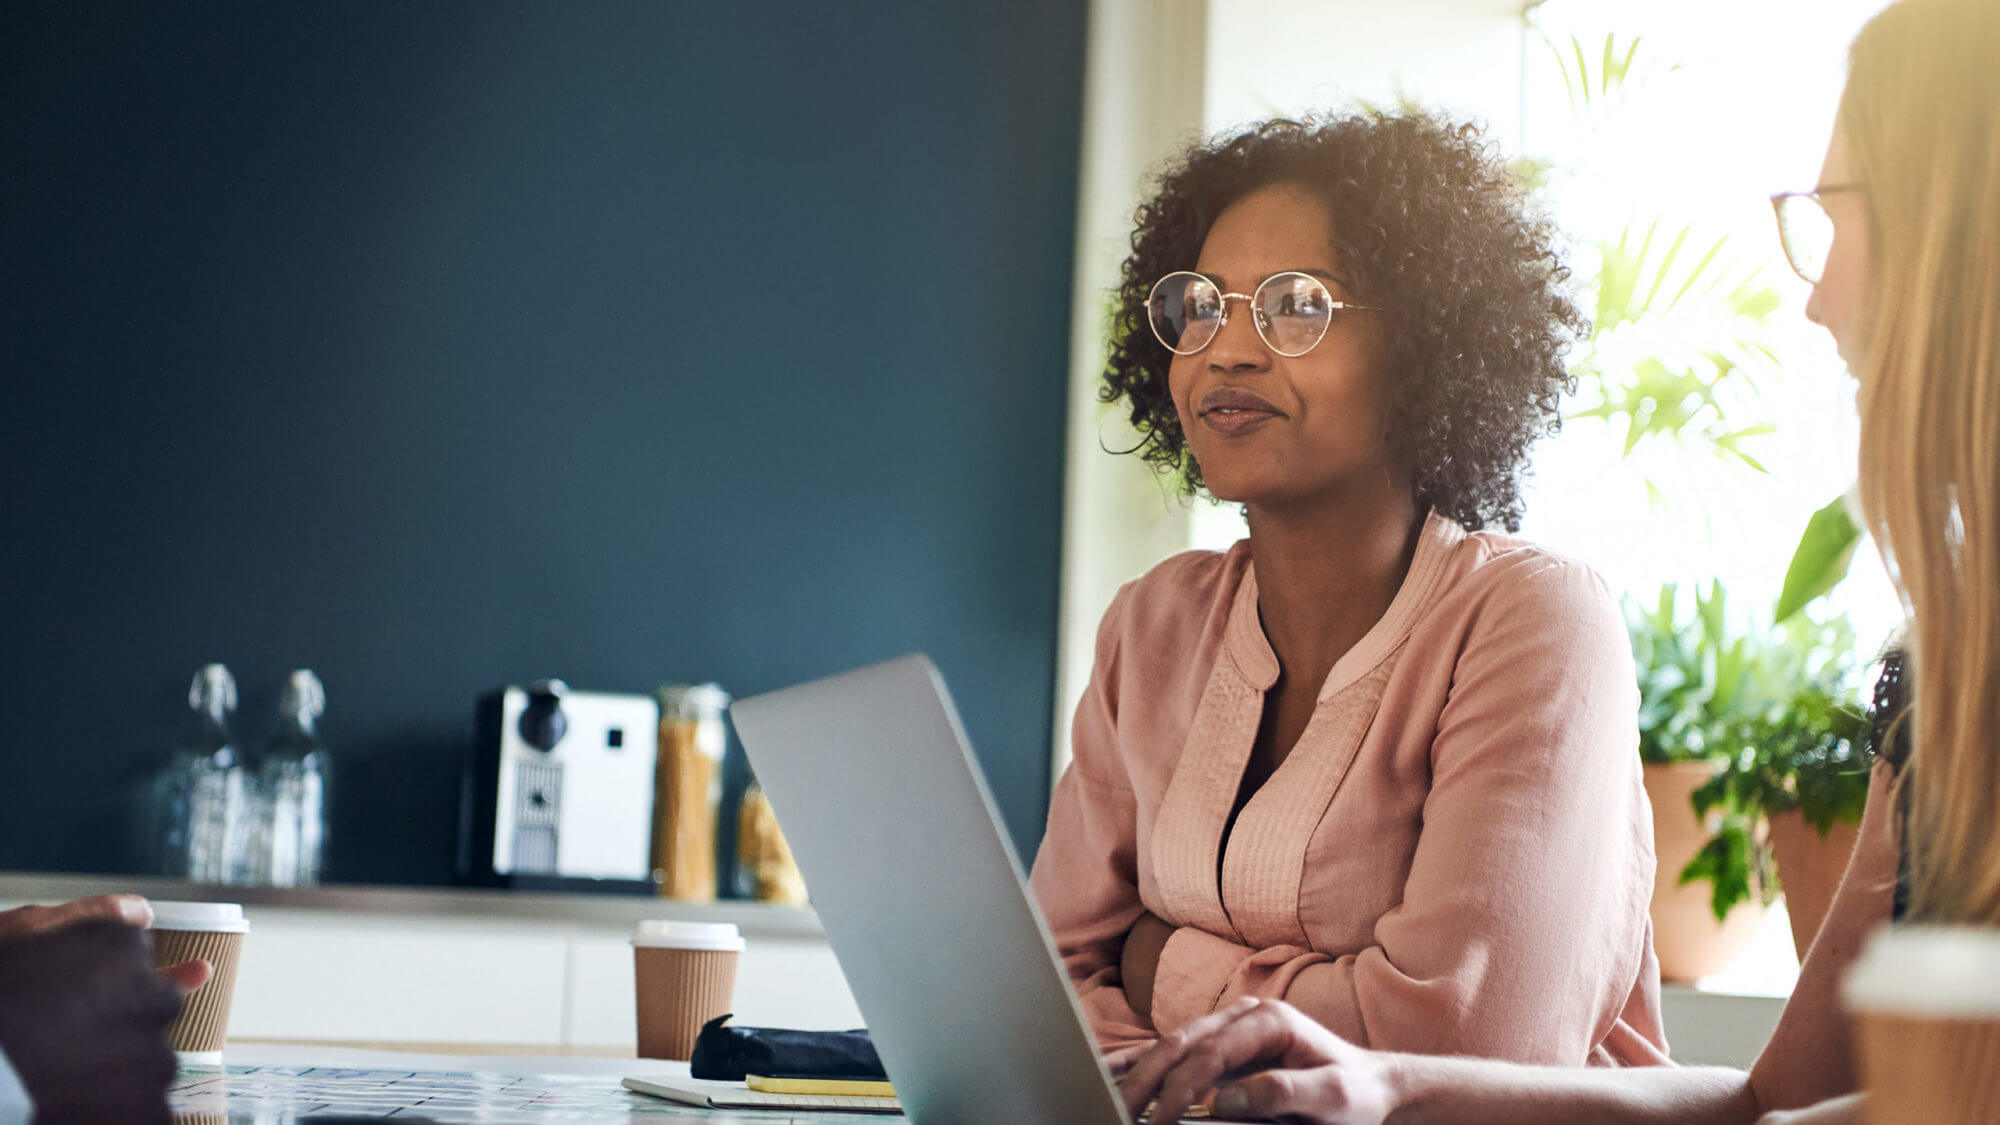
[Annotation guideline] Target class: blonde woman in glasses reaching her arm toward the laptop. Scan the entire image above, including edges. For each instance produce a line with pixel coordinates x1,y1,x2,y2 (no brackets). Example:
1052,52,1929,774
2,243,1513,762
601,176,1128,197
1116,0,2000,1125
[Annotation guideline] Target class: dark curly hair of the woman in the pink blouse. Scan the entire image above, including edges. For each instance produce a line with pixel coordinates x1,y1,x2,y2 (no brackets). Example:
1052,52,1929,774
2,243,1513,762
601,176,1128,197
1098,112,1588,530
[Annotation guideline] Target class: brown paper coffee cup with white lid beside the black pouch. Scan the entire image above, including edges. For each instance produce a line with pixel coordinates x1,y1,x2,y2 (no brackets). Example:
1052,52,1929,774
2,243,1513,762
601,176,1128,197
632,921,744,1059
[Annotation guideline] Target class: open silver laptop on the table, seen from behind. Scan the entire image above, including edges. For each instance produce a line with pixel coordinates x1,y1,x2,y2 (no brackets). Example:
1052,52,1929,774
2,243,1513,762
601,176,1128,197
730,657,1130,1125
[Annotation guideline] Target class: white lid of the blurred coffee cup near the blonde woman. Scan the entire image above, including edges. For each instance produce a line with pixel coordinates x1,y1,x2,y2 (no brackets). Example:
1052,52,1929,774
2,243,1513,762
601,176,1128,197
1844,927,2000,1019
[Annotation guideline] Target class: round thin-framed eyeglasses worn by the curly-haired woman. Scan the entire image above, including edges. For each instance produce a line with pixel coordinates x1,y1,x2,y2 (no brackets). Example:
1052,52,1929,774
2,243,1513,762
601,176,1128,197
1146,270,1372,358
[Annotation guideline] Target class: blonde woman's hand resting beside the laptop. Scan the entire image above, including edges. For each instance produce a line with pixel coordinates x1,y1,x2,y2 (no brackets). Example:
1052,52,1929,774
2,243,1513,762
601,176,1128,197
1110,992,1396,1125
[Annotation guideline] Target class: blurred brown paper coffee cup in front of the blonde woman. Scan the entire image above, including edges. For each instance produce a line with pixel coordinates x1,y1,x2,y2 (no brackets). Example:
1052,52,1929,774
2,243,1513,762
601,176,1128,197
1846,927,2000,1125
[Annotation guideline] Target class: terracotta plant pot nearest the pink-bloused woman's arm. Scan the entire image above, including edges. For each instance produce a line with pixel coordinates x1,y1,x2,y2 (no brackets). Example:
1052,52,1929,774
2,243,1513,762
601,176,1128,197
1646,763,1764,981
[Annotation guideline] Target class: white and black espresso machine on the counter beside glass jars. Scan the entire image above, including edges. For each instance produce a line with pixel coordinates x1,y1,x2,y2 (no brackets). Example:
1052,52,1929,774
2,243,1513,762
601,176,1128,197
458,681,660,893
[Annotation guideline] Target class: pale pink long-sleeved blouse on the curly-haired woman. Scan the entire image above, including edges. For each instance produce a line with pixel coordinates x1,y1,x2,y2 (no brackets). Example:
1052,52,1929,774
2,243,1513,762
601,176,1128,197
1032,514,1666,1065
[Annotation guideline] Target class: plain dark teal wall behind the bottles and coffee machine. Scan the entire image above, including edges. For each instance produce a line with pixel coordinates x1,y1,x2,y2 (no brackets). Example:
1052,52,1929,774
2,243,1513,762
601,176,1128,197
0,0,1084,883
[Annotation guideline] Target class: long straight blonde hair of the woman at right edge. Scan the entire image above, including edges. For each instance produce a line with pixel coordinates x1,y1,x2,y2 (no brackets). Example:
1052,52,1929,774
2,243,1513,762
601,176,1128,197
1840,0,2000,925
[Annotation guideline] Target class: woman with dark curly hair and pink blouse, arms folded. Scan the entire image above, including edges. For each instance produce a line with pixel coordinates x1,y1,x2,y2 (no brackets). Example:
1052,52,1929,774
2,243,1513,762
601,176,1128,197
1034,114,1666,1065
